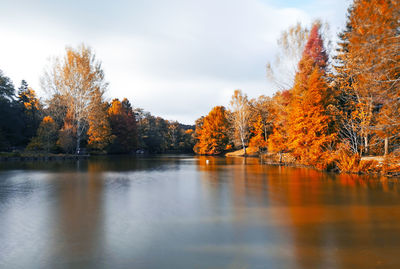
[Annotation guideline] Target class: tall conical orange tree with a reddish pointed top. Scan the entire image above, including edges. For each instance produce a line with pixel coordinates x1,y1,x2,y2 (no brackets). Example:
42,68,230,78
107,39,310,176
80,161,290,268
288,24,335,168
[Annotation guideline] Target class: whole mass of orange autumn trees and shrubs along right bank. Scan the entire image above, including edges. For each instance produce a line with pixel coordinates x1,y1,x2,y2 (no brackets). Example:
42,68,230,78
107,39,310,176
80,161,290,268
195,0,400,174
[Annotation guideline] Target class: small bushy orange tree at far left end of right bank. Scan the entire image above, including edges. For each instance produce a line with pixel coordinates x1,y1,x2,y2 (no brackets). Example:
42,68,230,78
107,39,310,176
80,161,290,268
194,106,229,155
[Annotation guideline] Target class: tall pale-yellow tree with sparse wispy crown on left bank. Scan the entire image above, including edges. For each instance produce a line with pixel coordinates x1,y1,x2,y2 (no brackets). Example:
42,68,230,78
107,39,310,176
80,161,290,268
43,45,108,153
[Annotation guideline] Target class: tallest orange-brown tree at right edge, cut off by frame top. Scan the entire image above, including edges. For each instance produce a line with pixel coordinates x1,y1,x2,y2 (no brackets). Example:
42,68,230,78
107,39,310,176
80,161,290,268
335,0,400,154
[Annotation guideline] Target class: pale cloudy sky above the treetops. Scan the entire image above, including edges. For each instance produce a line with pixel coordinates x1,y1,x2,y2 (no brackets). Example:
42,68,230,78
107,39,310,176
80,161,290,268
0,0,350,124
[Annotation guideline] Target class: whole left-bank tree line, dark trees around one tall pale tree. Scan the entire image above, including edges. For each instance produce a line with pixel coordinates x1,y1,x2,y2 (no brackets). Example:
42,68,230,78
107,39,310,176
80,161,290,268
0,45,194,154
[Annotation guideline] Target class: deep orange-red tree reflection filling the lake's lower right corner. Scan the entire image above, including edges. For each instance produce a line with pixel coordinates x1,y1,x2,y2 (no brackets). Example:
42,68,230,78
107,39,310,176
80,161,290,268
270,169,400,268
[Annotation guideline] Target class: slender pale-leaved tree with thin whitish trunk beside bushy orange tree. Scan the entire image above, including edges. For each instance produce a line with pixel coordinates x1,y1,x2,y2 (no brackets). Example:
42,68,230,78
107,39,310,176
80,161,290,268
230,90,251,156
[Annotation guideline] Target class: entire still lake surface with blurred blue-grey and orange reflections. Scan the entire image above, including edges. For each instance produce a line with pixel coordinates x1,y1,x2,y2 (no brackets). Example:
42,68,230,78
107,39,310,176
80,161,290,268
0,156,400,269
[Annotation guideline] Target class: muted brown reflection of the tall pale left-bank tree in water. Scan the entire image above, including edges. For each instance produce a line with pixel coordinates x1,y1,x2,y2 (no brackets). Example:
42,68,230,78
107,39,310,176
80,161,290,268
53,163,104,267
